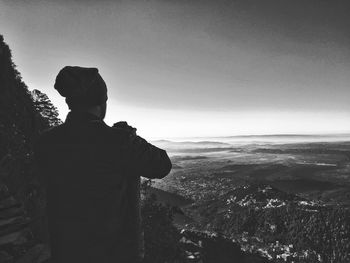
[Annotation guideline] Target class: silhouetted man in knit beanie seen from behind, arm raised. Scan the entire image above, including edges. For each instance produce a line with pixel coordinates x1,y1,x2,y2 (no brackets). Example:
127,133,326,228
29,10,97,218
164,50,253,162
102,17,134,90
35,66,171,263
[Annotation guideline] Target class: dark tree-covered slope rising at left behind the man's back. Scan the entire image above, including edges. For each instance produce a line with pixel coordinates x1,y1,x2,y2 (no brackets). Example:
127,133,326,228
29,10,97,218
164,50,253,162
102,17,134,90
0,35,60,262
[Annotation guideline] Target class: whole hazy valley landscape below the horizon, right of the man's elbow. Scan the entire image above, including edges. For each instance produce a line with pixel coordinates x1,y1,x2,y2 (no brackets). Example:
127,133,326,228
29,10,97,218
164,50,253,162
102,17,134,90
153,136,350,262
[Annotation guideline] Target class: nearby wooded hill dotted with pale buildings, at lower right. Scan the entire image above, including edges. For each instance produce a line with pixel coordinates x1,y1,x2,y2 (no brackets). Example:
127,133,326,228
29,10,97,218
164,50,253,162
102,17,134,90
187,184,350,263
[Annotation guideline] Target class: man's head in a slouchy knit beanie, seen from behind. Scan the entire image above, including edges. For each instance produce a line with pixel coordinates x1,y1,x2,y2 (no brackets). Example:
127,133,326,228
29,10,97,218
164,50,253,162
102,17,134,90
54,66,107,119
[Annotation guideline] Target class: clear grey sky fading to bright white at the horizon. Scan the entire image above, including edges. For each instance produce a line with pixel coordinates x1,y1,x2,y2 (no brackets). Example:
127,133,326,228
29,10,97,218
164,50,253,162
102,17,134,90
0,0,350,138
